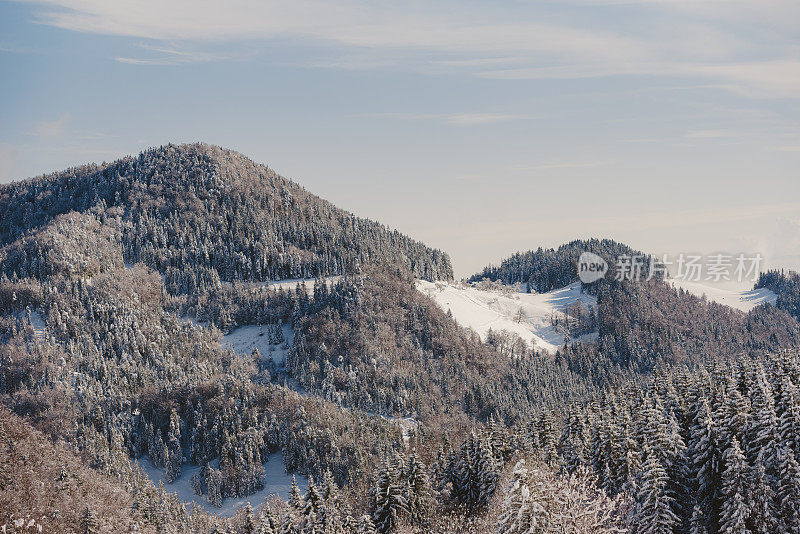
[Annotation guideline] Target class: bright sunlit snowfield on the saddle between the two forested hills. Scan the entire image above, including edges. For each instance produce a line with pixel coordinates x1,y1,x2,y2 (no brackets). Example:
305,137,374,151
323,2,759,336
416,280,597,352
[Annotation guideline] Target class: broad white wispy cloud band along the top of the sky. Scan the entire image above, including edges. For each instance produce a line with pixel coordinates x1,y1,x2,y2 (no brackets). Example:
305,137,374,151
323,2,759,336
17,0,800,98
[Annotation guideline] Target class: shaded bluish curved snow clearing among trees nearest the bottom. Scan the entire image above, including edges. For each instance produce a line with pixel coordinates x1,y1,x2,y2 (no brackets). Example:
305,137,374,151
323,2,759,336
136,452,308,515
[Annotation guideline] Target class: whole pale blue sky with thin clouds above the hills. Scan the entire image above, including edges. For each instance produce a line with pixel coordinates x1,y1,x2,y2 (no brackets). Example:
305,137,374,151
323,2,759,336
0,0,800,277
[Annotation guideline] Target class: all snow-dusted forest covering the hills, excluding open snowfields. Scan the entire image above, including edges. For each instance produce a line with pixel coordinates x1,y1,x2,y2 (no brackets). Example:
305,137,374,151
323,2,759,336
0,145,800,534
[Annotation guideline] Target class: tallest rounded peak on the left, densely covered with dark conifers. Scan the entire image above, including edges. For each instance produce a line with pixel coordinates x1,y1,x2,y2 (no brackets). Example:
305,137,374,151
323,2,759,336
0,144,452,293
